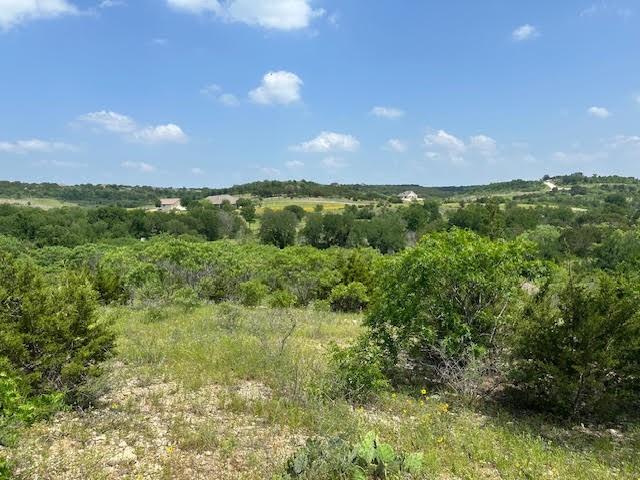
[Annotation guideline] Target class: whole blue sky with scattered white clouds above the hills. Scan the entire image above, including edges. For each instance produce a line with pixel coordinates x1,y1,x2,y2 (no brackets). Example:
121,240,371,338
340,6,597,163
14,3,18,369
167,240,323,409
0,0,640,186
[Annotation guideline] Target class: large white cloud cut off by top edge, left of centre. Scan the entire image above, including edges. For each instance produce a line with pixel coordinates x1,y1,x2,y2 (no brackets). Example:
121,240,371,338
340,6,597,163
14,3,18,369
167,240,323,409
167,0,325,31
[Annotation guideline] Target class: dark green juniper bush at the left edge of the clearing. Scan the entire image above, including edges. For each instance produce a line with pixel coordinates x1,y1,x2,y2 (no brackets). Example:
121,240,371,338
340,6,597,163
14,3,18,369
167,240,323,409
0,254,115,404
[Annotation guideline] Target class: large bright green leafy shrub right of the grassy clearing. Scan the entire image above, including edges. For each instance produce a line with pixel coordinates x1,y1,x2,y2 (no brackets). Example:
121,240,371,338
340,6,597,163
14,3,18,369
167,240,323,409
366,229,528,376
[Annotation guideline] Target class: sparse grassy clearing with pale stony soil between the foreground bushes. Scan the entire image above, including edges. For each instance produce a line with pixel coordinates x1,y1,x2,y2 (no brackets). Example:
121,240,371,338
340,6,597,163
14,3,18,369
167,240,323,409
6,305,640,480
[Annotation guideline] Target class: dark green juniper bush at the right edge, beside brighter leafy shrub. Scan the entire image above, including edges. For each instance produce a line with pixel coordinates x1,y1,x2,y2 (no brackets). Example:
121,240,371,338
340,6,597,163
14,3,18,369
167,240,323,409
511,274,640,417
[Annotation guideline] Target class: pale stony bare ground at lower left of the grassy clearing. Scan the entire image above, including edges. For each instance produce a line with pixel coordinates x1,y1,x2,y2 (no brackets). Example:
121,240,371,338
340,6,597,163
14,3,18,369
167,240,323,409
9,370,304,480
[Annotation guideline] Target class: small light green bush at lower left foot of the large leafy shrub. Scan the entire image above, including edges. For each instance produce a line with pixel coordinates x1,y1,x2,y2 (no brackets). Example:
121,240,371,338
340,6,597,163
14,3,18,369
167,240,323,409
327,337,389,403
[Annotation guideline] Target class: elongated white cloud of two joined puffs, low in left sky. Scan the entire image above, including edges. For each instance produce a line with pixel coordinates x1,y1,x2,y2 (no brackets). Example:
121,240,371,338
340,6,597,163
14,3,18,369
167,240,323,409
78,110,188,143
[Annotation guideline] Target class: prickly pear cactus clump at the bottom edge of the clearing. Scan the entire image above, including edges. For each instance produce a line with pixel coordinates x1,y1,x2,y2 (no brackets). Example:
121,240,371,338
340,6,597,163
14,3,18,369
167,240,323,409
283,432,423,480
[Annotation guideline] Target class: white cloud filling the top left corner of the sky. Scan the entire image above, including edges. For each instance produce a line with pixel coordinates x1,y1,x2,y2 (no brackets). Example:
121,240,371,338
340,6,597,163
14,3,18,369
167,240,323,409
0,0,80,31
